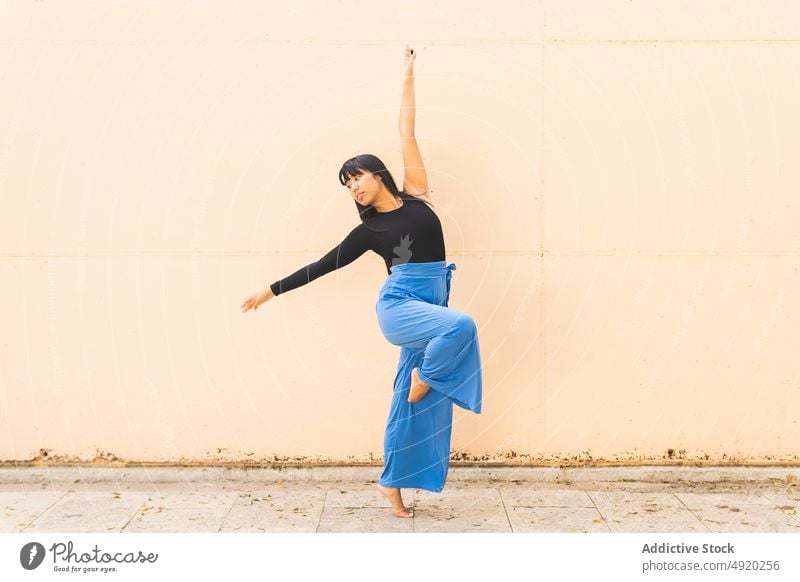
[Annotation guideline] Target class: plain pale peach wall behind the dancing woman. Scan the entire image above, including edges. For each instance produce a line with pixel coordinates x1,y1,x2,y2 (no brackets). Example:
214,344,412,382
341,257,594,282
0,0,800,462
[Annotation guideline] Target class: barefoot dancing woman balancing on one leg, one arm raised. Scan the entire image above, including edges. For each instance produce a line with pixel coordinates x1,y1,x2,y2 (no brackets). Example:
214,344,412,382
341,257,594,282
242,46,482,518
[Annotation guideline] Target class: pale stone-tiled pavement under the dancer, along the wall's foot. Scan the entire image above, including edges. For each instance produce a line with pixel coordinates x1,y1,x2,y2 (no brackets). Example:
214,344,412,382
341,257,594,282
0,468,800,533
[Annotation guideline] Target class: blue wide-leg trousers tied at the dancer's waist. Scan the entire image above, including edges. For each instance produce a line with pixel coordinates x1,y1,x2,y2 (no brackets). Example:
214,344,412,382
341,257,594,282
375,261,482,493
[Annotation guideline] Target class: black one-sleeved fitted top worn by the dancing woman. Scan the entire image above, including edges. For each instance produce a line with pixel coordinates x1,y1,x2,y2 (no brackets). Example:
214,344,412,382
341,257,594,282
269,192,445,295
